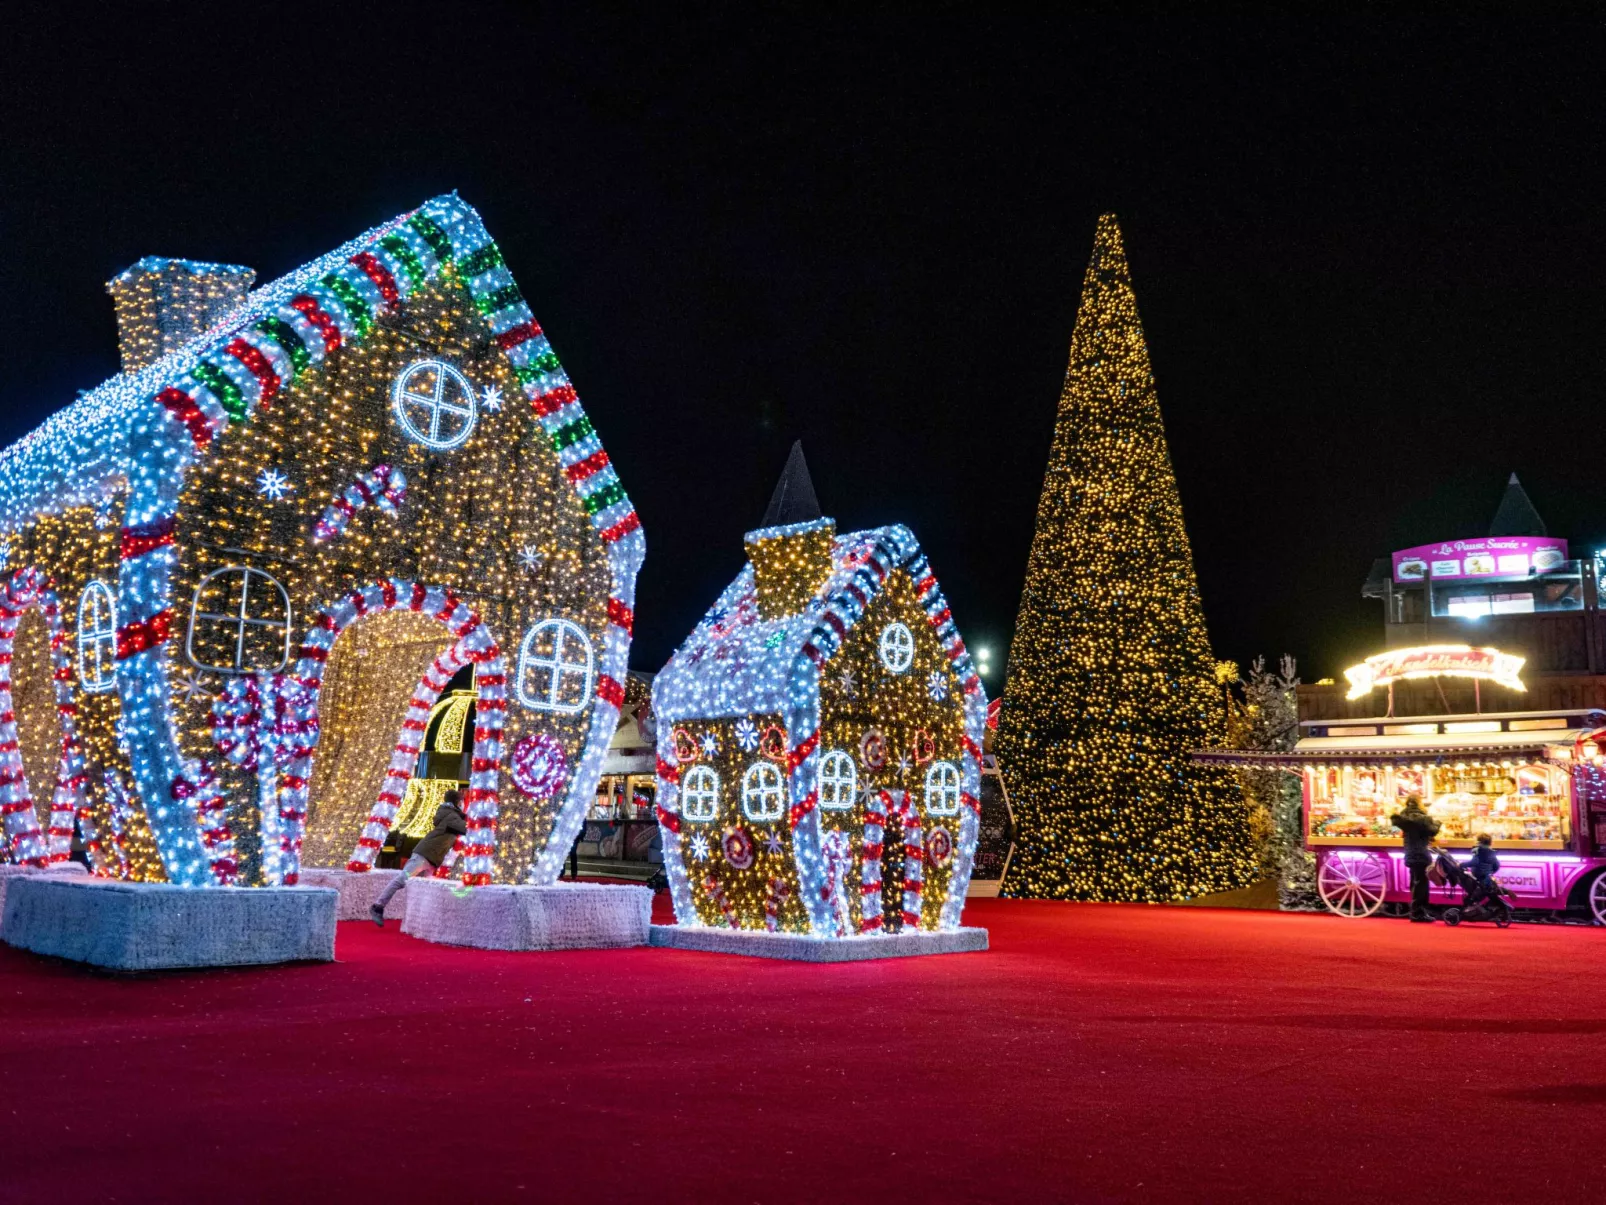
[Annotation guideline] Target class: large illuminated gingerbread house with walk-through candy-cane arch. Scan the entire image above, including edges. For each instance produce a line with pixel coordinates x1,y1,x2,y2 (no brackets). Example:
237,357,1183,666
0,194,644,885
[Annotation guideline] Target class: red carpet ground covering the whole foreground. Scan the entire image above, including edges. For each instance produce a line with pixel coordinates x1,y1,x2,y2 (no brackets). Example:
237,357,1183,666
0,900,1606,1205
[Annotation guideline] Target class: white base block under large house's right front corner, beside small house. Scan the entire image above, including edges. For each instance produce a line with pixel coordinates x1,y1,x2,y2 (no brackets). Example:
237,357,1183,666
402,879,652,950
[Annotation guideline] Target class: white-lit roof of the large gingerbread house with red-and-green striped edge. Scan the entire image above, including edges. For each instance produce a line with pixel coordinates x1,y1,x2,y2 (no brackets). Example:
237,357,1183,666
0,193,634,555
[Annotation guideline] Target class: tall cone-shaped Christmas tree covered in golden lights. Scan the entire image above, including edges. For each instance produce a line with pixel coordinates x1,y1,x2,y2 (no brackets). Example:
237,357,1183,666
994,214,1256,901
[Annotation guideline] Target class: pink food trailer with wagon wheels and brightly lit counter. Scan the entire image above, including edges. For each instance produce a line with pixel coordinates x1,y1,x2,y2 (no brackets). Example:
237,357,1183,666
1196,697,1606,924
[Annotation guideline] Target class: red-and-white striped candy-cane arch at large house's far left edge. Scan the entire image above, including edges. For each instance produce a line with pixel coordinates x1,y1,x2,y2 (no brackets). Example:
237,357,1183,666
0,566,85,866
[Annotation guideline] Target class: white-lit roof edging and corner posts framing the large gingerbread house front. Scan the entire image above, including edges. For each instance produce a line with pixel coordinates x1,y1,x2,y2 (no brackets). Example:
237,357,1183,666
0,196,644,884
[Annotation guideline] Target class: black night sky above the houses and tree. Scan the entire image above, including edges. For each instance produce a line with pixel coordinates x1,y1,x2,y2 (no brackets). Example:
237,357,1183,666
0,3,1606,692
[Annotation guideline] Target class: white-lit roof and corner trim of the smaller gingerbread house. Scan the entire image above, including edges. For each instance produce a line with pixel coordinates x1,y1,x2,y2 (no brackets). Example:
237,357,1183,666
654,521,986,937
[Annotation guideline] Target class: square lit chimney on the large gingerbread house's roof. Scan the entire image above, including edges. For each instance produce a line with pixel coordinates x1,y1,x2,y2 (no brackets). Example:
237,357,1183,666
106,255,257,373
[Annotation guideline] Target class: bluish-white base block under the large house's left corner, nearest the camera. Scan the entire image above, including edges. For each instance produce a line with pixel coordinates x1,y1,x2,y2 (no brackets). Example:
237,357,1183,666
0,874,339,970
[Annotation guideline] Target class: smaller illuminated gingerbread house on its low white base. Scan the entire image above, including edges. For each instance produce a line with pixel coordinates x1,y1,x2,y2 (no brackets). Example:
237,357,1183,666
652,445,986,961
